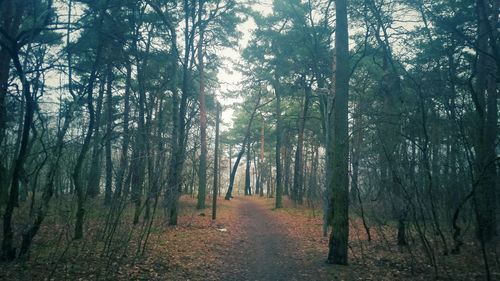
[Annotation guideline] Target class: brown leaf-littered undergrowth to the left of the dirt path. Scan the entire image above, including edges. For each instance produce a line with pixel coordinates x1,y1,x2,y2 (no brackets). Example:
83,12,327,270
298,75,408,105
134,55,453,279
0,197,240,280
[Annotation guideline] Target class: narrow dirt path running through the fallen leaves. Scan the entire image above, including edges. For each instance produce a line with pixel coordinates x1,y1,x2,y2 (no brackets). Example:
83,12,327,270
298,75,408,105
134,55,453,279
222,198,322,281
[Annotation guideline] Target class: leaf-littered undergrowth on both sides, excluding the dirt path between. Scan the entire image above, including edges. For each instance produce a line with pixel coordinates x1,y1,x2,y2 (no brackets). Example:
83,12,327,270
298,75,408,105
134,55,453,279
0,197,500,280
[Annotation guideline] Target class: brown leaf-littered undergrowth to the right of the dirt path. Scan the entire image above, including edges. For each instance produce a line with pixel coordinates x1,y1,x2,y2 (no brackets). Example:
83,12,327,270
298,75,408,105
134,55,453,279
260,195,500,281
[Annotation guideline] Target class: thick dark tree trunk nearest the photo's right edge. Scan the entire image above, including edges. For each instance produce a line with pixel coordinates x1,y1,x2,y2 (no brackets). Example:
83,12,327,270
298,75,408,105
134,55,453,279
472,0,498,241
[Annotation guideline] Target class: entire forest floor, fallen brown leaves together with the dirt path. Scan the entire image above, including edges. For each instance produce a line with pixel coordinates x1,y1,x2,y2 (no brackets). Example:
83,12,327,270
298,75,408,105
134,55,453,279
0,197,500,281
